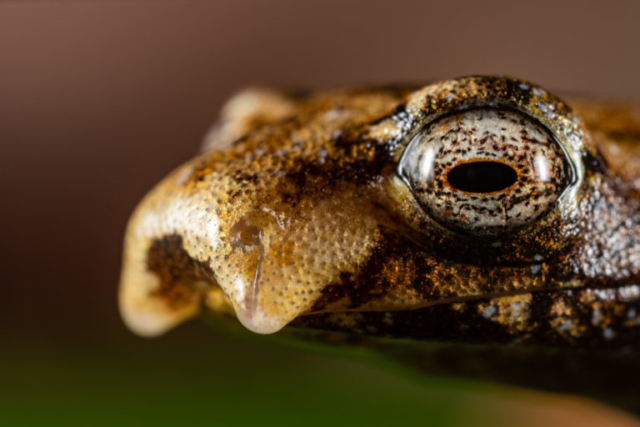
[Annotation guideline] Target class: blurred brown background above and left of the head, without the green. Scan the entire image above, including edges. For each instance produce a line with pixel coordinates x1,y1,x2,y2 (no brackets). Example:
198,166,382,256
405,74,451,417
0,0,640,427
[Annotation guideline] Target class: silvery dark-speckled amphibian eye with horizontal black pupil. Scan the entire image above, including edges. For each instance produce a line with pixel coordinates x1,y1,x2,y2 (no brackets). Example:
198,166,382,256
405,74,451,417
398,108,574,236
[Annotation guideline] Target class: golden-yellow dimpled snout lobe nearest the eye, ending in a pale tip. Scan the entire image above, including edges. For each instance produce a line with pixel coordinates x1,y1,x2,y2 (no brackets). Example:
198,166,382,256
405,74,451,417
210,201,379,334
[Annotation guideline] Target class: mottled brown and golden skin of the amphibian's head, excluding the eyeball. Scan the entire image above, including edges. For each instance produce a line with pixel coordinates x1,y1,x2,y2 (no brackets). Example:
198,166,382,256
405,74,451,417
120,77,640,410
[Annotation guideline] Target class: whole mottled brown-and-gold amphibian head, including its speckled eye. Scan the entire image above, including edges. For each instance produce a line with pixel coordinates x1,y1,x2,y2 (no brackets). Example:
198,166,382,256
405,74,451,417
119,76,640,414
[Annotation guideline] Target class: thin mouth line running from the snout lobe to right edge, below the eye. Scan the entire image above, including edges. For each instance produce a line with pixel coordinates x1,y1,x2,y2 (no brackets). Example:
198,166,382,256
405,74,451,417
300,284,640,317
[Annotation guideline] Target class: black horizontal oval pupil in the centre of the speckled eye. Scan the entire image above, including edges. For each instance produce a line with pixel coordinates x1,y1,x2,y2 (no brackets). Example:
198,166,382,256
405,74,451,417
447,161,518,193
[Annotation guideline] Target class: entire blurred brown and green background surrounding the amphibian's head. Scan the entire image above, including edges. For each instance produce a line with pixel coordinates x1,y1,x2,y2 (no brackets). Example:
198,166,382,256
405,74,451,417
0,0,640,426
